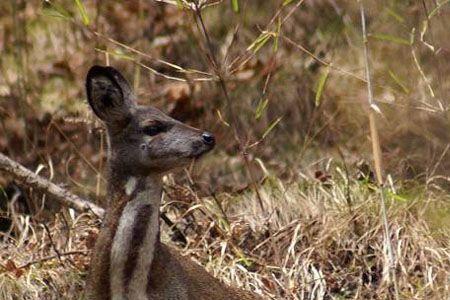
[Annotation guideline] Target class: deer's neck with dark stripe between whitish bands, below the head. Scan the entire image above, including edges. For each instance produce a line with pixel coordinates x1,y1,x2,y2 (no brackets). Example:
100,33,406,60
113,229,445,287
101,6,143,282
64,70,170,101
107,166,162,299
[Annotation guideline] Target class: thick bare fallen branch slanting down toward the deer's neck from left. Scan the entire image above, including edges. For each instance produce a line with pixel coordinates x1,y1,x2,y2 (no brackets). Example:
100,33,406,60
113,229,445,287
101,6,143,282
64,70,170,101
0,153,104,217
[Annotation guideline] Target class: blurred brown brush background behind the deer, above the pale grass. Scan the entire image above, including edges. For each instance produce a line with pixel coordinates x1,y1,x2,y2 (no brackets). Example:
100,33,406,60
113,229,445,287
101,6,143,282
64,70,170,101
0,0,450,299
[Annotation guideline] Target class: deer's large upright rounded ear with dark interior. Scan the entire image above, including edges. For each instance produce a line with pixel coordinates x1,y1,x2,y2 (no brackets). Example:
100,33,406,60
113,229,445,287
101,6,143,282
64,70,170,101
86,66,135,124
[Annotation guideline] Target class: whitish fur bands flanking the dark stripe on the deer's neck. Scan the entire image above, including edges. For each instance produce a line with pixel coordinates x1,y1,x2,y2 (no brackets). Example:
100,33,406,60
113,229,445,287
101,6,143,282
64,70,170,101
110,177,161,300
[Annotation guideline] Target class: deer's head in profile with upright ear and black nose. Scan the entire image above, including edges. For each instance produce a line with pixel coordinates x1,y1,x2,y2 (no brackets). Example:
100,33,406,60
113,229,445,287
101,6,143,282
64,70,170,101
86,66,215,176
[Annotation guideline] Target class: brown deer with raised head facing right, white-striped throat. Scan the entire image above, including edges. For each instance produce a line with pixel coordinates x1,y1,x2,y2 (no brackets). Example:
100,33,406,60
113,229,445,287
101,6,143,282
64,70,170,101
85,65,262,300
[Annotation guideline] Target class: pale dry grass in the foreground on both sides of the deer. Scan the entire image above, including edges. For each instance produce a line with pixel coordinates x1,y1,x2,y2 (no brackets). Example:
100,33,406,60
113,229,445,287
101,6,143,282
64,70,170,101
0,167,450,300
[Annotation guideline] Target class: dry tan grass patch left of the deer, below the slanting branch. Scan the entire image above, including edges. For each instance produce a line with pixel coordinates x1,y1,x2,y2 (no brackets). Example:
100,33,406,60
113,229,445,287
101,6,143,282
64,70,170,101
0,214,94,300
